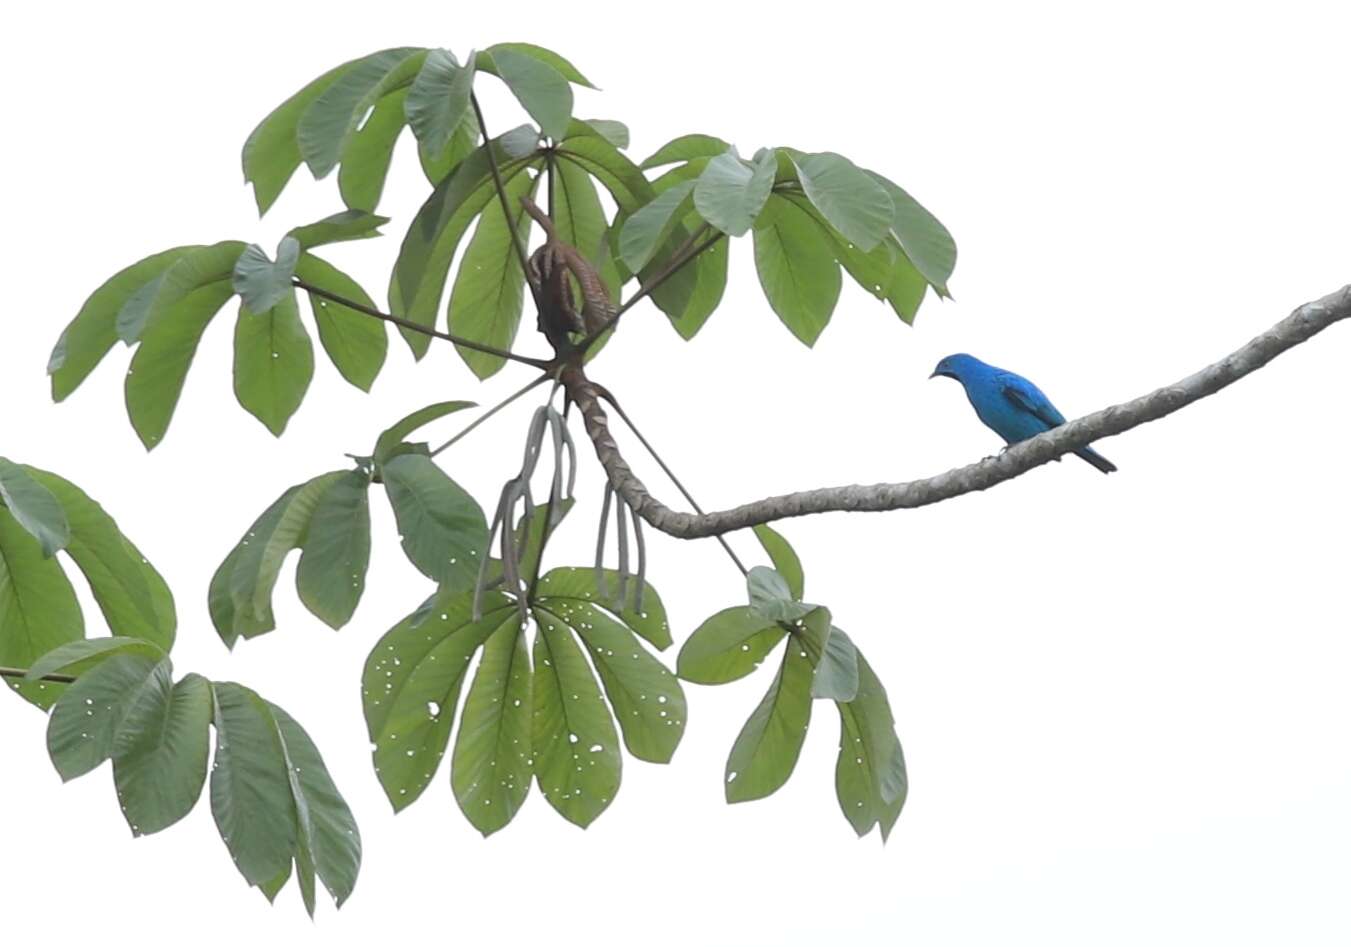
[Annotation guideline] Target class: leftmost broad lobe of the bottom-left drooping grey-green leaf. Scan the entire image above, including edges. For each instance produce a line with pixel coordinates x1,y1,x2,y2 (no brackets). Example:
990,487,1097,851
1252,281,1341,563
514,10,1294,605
47,652,173,781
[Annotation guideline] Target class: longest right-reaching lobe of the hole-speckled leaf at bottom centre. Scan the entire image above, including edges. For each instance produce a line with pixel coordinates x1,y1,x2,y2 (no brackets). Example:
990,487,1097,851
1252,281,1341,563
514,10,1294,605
535,597,686,763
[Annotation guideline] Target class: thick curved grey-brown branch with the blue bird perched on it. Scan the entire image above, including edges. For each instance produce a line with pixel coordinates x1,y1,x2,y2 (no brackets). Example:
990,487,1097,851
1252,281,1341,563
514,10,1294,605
561,280,1351,539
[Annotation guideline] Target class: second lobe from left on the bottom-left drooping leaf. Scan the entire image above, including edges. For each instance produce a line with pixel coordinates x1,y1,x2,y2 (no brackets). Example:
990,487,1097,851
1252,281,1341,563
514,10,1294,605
113,664,212,835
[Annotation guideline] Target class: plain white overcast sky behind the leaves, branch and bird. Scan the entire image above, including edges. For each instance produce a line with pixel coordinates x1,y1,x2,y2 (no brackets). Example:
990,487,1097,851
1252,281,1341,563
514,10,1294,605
0,0,1351,947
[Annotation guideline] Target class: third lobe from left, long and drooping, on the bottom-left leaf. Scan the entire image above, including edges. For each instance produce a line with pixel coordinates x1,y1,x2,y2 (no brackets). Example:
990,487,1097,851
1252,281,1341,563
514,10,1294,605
211,682,297,885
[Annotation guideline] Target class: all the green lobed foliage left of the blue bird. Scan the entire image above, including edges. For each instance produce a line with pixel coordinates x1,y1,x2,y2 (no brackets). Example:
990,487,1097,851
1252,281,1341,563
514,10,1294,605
10,43,957,909
